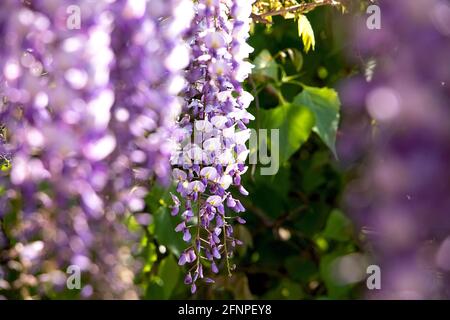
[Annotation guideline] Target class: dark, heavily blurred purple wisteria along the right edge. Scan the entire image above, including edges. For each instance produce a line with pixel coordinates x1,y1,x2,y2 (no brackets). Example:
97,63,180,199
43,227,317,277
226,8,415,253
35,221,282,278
339,0,450,299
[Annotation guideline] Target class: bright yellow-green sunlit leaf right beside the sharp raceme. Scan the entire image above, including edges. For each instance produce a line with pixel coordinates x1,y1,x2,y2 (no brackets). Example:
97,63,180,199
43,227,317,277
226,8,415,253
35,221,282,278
260,104,314,164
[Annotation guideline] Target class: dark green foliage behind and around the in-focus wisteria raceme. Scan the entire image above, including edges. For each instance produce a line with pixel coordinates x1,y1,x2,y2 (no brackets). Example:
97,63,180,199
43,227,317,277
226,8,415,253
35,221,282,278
142,3,368,299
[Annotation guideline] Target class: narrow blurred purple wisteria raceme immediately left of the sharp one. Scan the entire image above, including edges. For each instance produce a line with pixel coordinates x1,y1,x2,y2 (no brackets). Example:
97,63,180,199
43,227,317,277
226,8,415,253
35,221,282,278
111,0,193,190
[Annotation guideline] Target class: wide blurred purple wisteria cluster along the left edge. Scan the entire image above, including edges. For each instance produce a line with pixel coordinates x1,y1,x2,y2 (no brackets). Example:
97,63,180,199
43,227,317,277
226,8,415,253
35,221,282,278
0,1,134,297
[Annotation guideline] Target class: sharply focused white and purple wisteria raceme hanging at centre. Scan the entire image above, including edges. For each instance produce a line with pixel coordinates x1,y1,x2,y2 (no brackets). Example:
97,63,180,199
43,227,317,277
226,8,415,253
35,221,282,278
172,0,254,292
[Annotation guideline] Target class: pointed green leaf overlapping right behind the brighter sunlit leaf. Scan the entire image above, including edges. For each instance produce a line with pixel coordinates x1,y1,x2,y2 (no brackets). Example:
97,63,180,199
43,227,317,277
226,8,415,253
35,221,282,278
293,86,341,156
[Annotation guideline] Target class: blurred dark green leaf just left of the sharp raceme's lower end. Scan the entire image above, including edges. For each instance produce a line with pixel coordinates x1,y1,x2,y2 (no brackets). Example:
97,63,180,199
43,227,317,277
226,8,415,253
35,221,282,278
154,207,187,256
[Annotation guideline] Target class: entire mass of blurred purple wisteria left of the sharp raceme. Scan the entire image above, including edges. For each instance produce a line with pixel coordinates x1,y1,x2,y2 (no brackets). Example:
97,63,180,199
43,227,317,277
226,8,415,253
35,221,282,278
0,0,191,298
